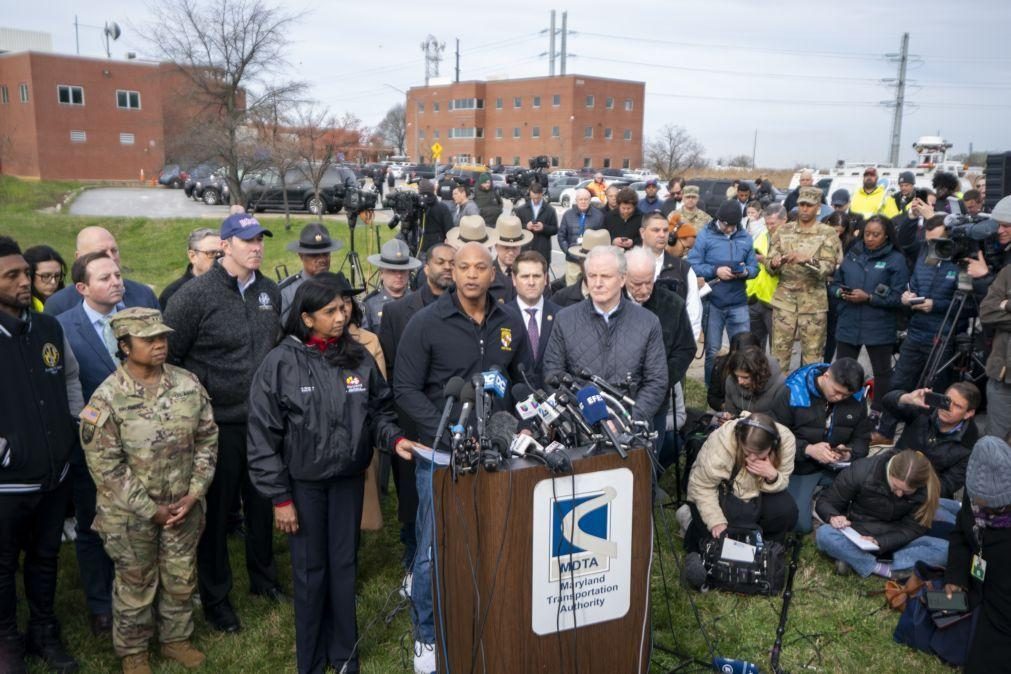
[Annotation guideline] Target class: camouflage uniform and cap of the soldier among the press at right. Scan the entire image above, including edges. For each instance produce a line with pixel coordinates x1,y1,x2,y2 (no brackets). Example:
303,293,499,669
767,187,841,372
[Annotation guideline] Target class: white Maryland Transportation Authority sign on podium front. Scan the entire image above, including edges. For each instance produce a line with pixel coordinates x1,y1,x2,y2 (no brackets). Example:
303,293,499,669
531,468,635,635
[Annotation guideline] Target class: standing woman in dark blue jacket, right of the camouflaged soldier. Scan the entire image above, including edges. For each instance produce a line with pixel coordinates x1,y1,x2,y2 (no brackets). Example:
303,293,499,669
828,215,909,411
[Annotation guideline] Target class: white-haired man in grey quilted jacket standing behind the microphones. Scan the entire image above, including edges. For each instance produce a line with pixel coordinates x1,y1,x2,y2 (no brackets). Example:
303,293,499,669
543,246,667,421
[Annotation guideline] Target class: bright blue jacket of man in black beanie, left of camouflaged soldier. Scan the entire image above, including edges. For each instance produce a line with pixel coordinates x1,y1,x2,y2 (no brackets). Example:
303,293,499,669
688,220,758,309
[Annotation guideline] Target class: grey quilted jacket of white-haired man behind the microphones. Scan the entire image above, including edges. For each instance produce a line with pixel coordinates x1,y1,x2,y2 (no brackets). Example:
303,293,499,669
543,295,669,419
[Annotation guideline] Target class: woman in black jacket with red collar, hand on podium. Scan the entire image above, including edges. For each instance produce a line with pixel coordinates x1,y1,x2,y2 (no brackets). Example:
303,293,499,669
248,273,412,672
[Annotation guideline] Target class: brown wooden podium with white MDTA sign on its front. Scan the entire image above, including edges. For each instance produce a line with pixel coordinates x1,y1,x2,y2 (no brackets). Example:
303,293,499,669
433,449,653,674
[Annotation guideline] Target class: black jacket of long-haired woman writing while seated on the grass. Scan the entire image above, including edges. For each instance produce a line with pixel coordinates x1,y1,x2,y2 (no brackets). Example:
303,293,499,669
815,450,927,554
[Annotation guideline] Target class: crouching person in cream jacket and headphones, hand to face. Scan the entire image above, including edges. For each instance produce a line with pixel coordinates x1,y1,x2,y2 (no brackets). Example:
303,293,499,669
684,413,797,573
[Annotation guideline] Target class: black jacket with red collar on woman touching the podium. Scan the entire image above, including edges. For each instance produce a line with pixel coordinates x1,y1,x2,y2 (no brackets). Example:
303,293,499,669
247,336,403,503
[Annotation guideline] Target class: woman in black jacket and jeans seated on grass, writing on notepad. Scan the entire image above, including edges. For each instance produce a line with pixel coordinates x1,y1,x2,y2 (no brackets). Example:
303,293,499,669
815,450,947,578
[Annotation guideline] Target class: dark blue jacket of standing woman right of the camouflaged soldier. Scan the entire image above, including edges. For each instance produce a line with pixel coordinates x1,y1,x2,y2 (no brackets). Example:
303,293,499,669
828,242,909,346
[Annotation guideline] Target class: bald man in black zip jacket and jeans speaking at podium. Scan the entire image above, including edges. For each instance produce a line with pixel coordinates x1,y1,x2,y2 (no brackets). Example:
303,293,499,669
393,243,537,674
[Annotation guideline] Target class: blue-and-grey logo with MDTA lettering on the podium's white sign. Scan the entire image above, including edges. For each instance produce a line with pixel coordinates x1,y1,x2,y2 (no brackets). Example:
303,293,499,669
549,487,618,582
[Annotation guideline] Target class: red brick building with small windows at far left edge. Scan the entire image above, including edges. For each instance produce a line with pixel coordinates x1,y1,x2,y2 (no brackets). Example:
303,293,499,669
0,52,165,180
